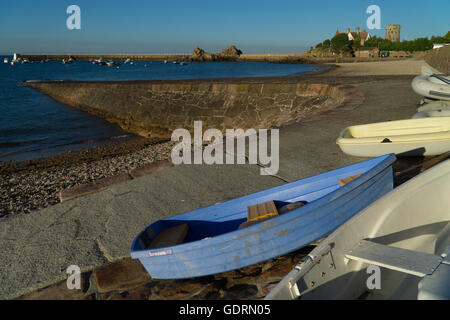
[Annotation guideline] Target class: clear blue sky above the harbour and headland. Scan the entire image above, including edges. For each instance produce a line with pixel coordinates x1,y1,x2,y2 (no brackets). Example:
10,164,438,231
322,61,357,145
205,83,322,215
0,0,450,54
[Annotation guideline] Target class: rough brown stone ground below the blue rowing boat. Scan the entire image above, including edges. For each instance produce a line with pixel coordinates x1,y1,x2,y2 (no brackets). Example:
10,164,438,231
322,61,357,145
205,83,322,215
16,247,312,300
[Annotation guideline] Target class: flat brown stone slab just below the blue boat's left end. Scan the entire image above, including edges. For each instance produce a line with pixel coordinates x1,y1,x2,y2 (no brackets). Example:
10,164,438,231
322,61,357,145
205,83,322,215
93,258,151,292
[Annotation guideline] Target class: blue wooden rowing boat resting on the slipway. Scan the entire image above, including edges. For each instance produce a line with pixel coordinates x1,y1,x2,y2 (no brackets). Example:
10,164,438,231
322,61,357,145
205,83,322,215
131,154,396,279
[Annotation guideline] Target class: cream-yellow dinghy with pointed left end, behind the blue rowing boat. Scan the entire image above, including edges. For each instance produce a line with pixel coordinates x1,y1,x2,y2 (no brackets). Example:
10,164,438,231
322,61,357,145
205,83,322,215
336,117,450,157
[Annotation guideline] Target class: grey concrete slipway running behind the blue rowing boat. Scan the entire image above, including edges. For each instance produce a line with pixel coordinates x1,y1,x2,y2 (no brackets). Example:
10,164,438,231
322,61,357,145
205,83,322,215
0,76,419,299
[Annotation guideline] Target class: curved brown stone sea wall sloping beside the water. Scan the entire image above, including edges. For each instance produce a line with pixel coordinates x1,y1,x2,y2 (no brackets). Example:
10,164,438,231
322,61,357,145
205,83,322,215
25,81,357,138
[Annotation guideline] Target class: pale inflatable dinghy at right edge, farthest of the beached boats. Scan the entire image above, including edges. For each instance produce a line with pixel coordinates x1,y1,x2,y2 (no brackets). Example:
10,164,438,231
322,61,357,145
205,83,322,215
411,67,450,101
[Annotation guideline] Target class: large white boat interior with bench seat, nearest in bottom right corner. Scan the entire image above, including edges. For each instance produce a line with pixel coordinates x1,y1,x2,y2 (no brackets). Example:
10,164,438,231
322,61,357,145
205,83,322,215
266,160,450,300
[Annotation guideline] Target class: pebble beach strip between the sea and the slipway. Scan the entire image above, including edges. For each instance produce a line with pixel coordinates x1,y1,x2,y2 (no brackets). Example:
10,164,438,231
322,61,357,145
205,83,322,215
0,137,174,219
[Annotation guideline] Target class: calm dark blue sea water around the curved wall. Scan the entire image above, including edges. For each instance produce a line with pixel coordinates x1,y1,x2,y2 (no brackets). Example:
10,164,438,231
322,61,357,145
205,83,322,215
0,57,320,162
